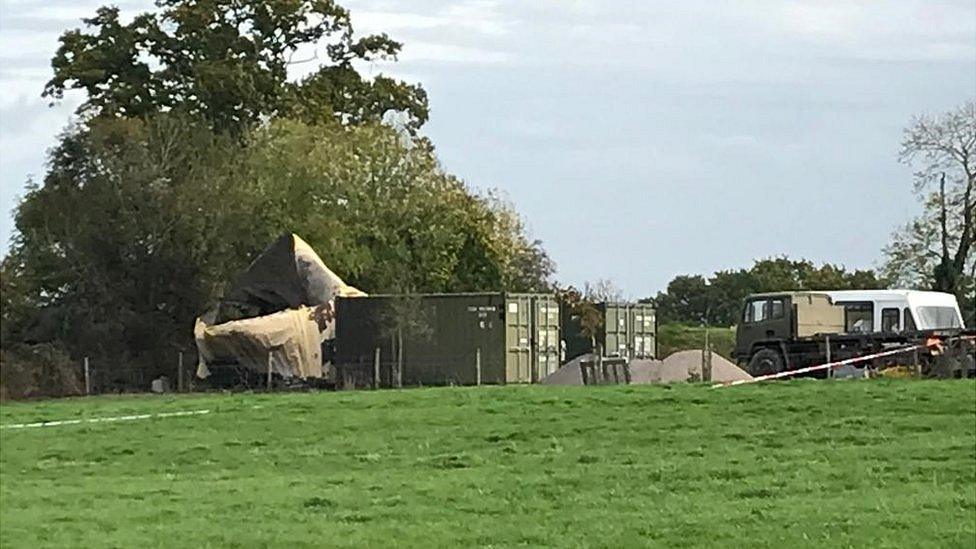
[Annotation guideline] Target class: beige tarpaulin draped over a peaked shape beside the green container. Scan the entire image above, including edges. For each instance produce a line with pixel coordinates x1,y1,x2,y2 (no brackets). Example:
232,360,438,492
193,234,366,379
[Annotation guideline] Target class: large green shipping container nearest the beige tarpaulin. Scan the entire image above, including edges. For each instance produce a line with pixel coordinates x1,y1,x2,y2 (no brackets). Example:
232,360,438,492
335,293,559,386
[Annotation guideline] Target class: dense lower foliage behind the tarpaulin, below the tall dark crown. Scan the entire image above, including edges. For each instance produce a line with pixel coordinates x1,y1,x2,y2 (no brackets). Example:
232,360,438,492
2,113,551,390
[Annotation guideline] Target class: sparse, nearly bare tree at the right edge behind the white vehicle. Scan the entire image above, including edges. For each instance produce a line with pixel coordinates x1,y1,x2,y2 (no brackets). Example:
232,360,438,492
885,101,976,322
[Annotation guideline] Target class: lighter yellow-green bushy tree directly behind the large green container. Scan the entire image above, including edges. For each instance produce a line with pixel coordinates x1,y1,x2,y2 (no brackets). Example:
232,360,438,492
251,121,552,293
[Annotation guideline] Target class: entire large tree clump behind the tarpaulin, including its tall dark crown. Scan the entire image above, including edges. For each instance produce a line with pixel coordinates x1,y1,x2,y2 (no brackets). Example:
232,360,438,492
0,0,553,395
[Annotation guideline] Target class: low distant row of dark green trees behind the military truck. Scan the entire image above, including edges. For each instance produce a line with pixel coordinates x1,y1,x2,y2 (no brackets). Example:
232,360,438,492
645,257,886,326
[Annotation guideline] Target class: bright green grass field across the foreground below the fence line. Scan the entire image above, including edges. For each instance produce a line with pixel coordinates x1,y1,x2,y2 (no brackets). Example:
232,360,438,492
0,380,976,548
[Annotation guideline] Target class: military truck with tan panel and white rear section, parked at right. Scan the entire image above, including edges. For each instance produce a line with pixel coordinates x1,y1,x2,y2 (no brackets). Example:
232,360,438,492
733,290,976,377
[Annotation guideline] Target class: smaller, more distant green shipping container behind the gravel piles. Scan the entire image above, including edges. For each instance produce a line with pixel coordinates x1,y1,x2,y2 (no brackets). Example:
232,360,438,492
560,302,657,361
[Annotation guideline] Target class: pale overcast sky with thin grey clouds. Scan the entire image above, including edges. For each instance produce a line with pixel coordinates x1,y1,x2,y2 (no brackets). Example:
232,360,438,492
0,0,976,298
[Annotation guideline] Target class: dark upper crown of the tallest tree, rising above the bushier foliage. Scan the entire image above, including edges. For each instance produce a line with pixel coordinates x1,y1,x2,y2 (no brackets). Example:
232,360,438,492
44,0,428,133
